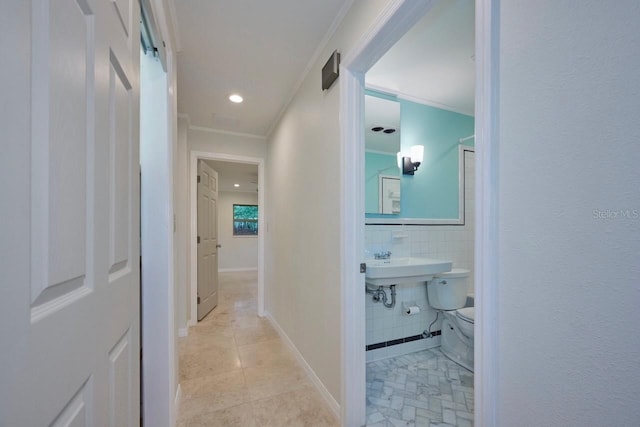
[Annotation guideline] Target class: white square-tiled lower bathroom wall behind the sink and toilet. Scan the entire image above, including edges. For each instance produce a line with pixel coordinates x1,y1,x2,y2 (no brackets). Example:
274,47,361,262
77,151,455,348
365,154,475,361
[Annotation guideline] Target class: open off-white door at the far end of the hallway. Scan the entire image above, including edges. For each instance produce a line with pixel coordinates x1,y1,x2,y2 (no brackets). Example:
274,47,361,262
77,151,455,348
198,160,220,320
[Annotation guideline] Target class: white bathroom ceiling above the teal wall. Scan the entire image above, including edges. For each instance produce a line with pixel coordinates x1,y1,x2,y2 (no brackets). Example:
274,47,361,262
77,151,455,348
365,0,475,115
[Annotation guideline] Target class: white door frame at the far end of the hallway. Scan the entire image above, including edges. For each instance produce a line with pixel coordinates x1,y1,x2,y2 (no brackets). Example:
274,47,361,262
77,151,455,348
188,150,266,325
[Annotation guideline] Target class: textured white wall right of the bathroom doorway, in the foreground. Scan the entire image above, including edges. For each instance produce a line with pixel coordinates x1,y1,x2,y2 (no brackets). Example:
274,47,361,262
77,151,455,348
495,0,640,426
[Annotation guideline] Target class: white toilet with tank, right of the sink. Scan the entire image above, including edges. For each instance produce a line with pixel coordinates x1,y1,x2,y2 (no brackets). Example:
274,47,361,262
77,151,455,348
427,268,475,372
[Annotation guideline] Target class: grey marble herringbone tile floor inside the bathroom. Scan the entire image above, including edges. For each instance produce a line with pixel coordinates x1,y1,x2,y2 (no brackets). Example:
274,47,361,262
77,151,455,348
366,348,473,427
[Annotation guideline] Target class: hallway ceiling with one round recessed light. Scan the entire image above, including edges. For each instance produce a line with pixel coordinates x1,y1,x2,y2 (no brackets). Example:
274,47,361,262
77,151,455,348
173,0,352,136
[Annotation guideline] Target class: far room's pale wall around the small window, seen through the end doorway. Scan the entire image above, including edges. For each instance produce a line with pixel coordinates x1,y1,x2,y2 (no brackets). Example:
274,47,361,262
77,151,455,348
218,191,262,271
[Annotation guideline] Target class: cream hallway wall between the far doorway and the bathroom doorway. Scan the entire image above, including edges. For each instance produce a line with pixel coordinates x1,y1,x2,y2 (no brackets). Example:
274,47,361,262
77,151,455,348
265,0,387,408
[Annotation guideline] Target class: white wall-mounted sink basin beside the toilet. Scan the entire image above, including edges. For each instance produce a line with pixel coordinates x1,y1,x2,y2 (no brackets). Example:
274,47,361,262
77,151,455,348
365,257,452,286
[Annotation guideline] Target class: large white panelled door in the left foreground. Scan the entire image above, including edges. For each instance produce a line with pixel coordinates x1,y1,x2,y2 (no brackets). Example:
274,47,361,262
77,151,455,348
0,0,140,426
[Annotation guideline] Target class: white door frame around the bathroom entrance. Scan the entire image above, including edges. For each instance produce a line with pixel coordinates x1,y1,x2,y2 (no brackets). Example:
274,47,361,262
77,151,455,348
340,0,499,427
